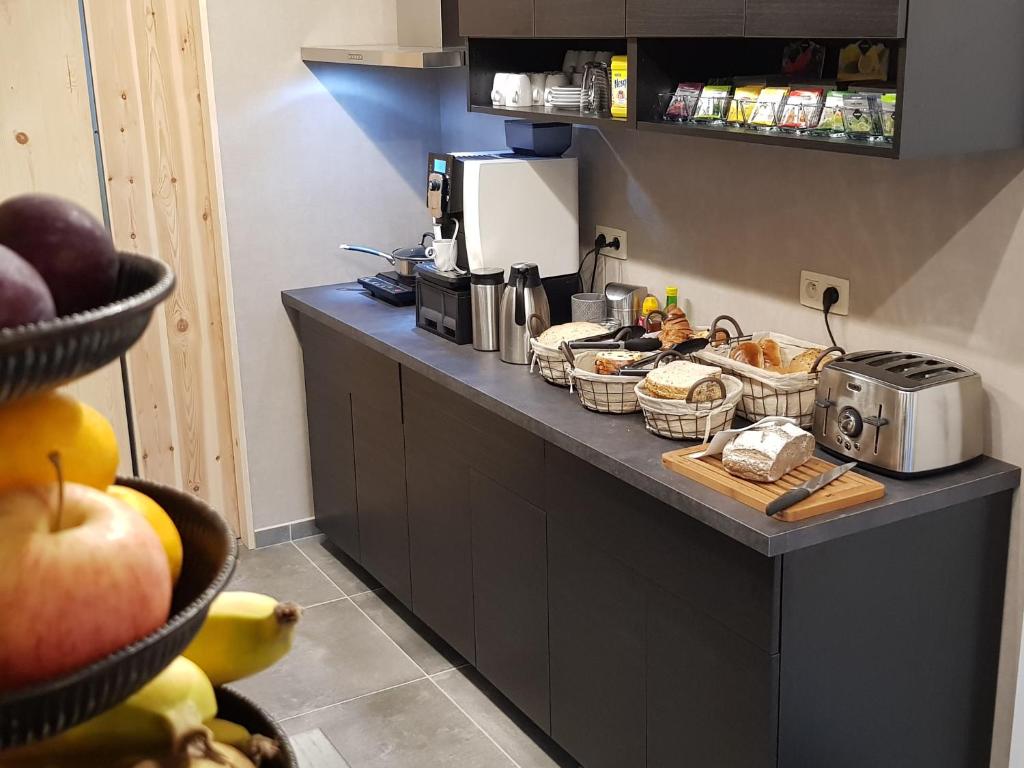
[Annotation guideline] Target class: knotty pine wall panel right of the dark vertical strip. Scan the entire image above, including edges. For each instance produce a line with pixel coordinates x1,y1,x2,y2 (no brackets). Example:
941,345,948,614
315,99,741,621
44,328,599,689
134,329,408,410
85,0,249,538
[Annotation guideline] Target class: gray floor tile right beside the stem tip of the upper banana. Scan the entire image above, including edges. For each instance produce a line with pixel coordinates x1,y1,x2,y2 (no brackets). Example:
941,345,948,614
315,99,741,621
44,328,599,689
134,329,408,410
232,600,423,719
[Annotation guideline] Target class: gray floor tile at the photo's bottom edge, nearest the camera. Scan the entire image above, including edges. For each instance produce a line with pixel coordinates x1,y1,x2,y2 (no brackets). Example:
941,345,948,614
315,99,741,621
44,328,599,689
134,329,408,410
283,680,513,768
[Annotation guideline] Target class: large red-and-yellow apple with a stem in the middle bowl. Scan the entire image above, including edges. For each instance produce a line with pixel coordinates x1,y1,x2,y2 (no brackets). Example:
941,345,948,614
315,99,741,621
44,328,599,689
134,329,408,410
0,482,171,691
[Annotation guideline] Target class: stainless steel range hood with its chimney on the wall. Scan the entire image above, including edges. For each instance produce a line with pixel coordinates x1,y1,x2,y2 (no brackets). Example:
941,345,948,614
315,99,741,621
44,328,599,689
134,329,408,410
302,0,466,70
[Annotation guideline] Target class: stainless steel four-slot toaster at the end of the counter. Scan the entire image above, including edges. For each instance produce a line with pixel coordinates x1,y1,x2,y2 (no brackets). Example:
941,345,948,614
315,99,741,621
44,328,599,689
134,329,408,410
813,351,984,475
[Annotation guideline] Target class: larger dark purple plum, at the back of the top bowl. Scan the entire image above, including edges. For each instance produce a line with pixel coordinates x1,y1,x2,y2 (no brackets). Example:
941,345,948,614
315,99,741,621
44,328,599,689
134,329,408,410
0,195,118,315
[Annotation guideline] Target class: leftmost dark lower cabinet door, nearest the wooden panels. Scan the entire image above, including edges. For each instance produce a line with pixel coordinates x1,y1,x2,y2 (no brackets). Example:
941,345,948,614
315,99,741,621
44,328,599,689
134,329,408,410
299,315,359,560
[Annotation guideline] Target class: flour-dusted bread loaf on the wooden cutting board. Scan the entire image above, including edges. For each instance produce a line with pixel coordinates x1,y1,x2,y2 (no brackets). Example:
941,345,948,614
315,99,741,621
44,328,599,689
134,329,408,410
722,423,814,482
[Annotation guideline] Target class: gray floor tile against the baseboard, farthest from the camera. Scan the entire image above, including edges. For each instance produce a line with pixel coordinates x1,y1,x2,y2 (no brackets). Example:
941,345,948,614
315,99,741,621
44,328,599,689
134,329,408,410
229,542,342,605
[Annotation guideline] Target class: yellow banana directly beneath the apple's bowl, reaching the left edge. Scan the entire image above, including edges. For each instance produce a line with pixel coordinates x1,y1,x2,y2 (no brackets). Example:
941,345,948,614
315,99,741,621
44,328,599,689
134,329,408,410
0,656,217,768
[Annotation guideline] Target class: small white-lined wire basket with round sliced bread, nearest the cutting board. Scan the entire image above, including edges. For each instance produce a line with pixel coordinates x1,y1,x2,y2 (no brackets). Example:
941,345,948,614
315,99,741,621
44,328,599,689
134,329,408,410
636,375,743,440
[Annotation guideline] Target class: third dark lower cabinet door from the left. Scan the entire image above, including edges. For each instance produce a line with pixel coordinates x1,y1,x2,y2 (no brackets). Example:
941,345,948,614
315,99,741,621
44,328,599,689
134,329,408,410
402,382,476,662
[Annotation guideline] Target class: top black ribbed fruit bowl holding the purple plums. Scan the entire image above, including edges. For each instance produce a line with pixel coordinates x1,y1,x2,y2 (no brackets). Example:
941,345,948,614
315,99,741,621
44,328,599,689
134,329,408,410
0,253,174,404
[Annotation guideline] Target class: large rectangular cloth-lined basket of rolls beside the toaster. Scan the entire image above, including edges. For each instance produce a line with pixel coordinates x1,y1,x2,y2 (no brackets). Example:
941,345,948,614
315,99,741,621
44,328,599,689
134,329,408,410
695,315,844,428
